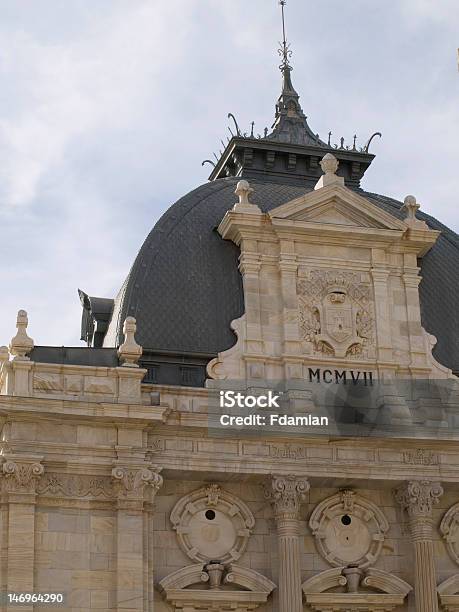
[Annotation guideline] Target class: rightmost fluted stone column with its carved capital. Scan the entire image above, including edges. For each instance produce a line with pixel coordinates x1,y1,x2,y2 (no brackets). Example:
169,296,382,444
396,480,443,612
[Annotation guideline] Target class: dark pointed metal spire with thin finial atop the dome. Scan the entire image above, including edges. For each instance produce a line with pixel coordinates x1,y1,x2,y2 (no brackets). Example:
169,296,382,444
266,0,325,146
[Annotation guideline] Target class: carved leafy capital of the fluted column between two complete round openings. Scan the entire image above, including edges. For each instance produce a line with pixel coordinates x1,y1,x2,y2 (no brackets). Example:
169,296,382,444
264,474,310,519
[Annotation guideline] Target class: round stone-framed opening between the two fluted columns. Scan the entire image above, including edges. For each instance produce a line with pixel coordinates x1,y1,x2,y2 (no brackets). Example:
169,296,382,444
309,490,389,568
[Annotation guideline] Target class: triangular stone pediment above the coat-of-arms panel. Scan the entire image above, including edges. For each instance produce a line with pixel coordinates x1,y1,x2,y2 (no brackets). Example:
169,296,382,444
269,184,407,231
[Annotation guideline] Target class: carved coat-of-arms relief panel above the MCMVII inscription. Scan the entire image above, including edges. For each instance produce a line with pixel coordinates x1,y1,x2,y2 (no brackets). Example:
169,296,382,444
297,270,376,358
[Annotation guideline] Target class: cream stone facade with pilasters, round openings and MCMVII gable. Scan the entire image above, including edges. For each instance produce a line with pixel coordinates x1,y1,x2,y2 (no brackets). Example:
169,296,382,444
0,156,459,612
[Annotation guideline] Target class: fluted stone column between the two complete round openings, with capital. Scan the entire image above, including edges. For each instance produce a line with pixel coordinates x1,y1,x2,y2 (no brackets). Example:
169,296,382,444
265,475,309,612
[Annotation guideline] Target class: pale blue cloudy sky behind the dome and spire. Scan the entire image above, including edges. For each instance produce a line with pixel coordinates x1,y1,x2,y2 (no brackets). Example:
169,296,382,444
0,0,459,346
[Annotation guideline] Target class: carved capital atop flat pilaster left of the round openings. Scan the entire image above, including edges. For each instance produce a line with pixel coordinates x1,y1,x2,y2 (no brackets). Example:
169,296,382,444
112,466,163,501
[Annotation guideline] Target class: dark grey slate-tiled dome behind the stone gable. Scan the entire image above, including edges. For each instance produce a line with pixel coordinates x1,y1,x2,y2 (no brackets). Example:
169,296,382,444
100,178,459,378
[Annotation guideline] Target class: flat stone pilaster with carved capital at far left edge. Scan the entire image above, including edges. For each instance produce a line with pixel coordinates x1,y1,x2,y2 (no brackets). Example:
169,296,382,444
2,455,45,612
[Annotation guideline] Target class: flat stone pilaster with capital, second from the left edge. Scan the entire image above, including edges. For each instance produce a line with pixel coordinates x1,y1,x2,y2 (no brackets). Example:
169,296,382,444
112,465,163,612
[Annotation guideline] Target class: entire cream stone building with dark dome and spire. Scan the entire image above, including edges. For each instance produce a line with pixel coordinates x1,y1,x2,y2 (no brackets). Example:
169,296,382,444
0,5,459,612
